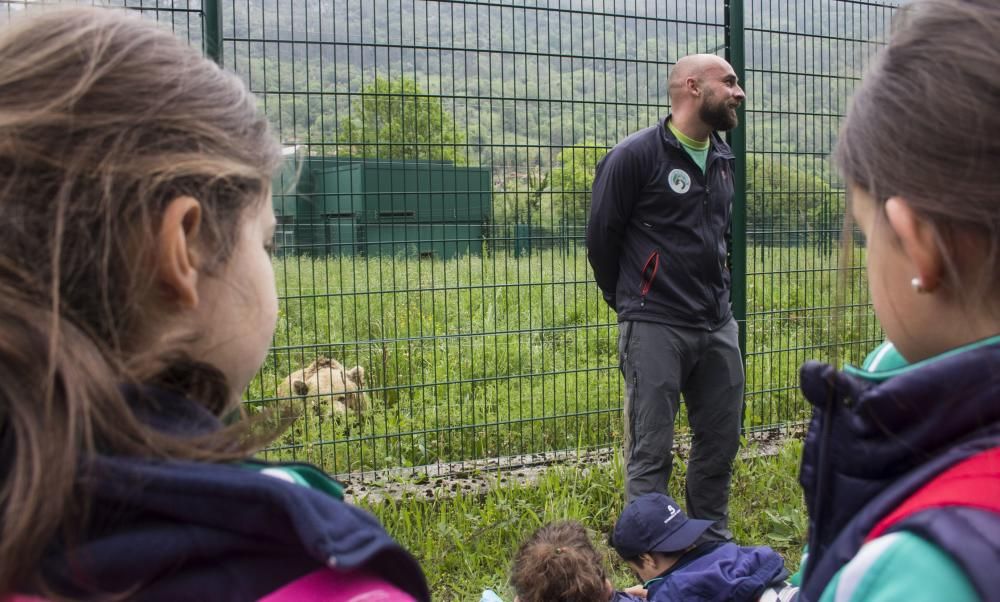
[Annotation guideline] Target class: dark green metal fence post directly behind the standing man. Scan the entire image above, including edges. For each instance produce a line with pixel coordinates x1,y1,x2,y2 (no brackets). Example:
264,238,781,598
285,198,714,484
726,0,747,432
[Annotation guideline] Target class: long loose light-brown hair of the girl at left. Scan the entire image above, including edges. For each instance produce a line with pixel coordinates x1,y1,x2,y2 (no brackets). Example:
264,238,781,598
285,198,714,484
0,8,281,597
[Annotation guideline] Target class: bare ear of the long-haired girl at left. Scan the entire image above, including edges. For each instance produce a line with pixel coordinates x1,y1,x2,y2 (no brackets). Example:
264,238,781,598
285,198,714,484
156,196,201,308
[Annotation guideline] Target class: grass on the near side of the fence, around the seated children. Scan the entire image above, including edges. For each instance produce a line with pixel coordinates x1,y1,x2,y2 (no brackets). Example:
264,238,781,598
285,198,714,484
361,440,806,602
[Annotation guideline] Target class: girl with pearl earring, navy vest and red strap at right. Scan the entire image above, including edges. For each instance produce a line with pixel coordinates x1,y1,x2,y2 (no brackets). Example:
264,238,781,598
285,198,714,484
784,0,1000,602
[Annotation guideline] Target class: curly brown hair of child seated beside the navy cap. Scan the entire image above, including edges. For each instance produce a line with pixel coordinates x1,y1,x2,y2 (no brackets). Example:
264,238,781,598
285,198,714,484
510,521,609,602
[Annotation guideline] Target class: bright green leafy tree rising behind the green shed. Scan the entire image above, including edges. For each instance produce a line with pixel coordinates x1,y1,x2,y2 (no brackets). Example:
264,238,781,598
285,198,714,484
337,77,466,165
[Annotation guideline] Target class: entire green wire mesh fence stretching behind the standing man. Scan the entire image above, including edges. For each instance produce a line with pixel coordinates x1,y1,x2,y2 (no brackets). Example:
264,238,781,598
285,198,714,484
0,0,898,479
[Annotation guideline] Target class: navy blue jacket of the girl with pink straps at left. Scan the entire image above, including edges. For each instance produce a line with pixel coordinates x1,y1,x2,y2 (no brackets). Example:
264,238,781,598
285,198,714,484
30,395,430,601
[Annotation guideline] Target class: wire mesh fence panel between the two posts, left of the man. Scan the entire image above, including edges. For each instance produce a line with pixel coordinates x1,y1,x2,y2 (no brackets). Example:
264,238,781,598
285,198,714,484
229,0,726,474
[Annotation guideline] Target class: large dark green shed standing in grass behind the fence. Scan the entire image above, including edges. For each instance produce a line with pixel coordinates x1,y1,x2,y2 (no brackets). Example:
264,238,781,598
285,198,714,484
273,157,492,258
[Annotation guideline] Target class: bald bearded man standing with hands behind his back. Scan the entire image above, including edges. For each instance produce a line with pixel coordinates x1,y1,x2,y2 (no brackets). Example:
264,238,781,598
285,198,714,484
587,54,745,540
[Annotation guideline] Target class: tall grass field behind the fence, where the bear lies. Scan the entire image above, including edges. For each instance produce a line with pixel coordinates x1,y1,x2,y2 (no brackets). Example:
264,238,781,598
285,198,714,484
247,246,879,474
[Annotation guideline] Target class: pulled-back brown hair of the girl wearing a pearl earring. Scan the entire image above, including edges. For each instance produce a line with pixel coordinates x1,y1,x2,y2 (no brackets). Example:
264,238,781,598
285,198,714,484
835,0,1000,311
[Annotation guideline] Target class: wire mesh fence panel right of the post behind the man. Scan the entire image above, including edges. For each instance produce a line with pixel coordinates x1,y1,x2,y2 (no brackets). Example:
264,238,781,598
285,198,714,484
744,0,898,429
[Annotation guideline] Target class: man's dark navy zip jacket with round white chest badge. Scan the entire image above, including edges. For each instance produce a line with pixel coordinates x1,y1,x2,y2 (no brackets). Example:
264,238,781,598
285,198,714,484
587,116,735,330
